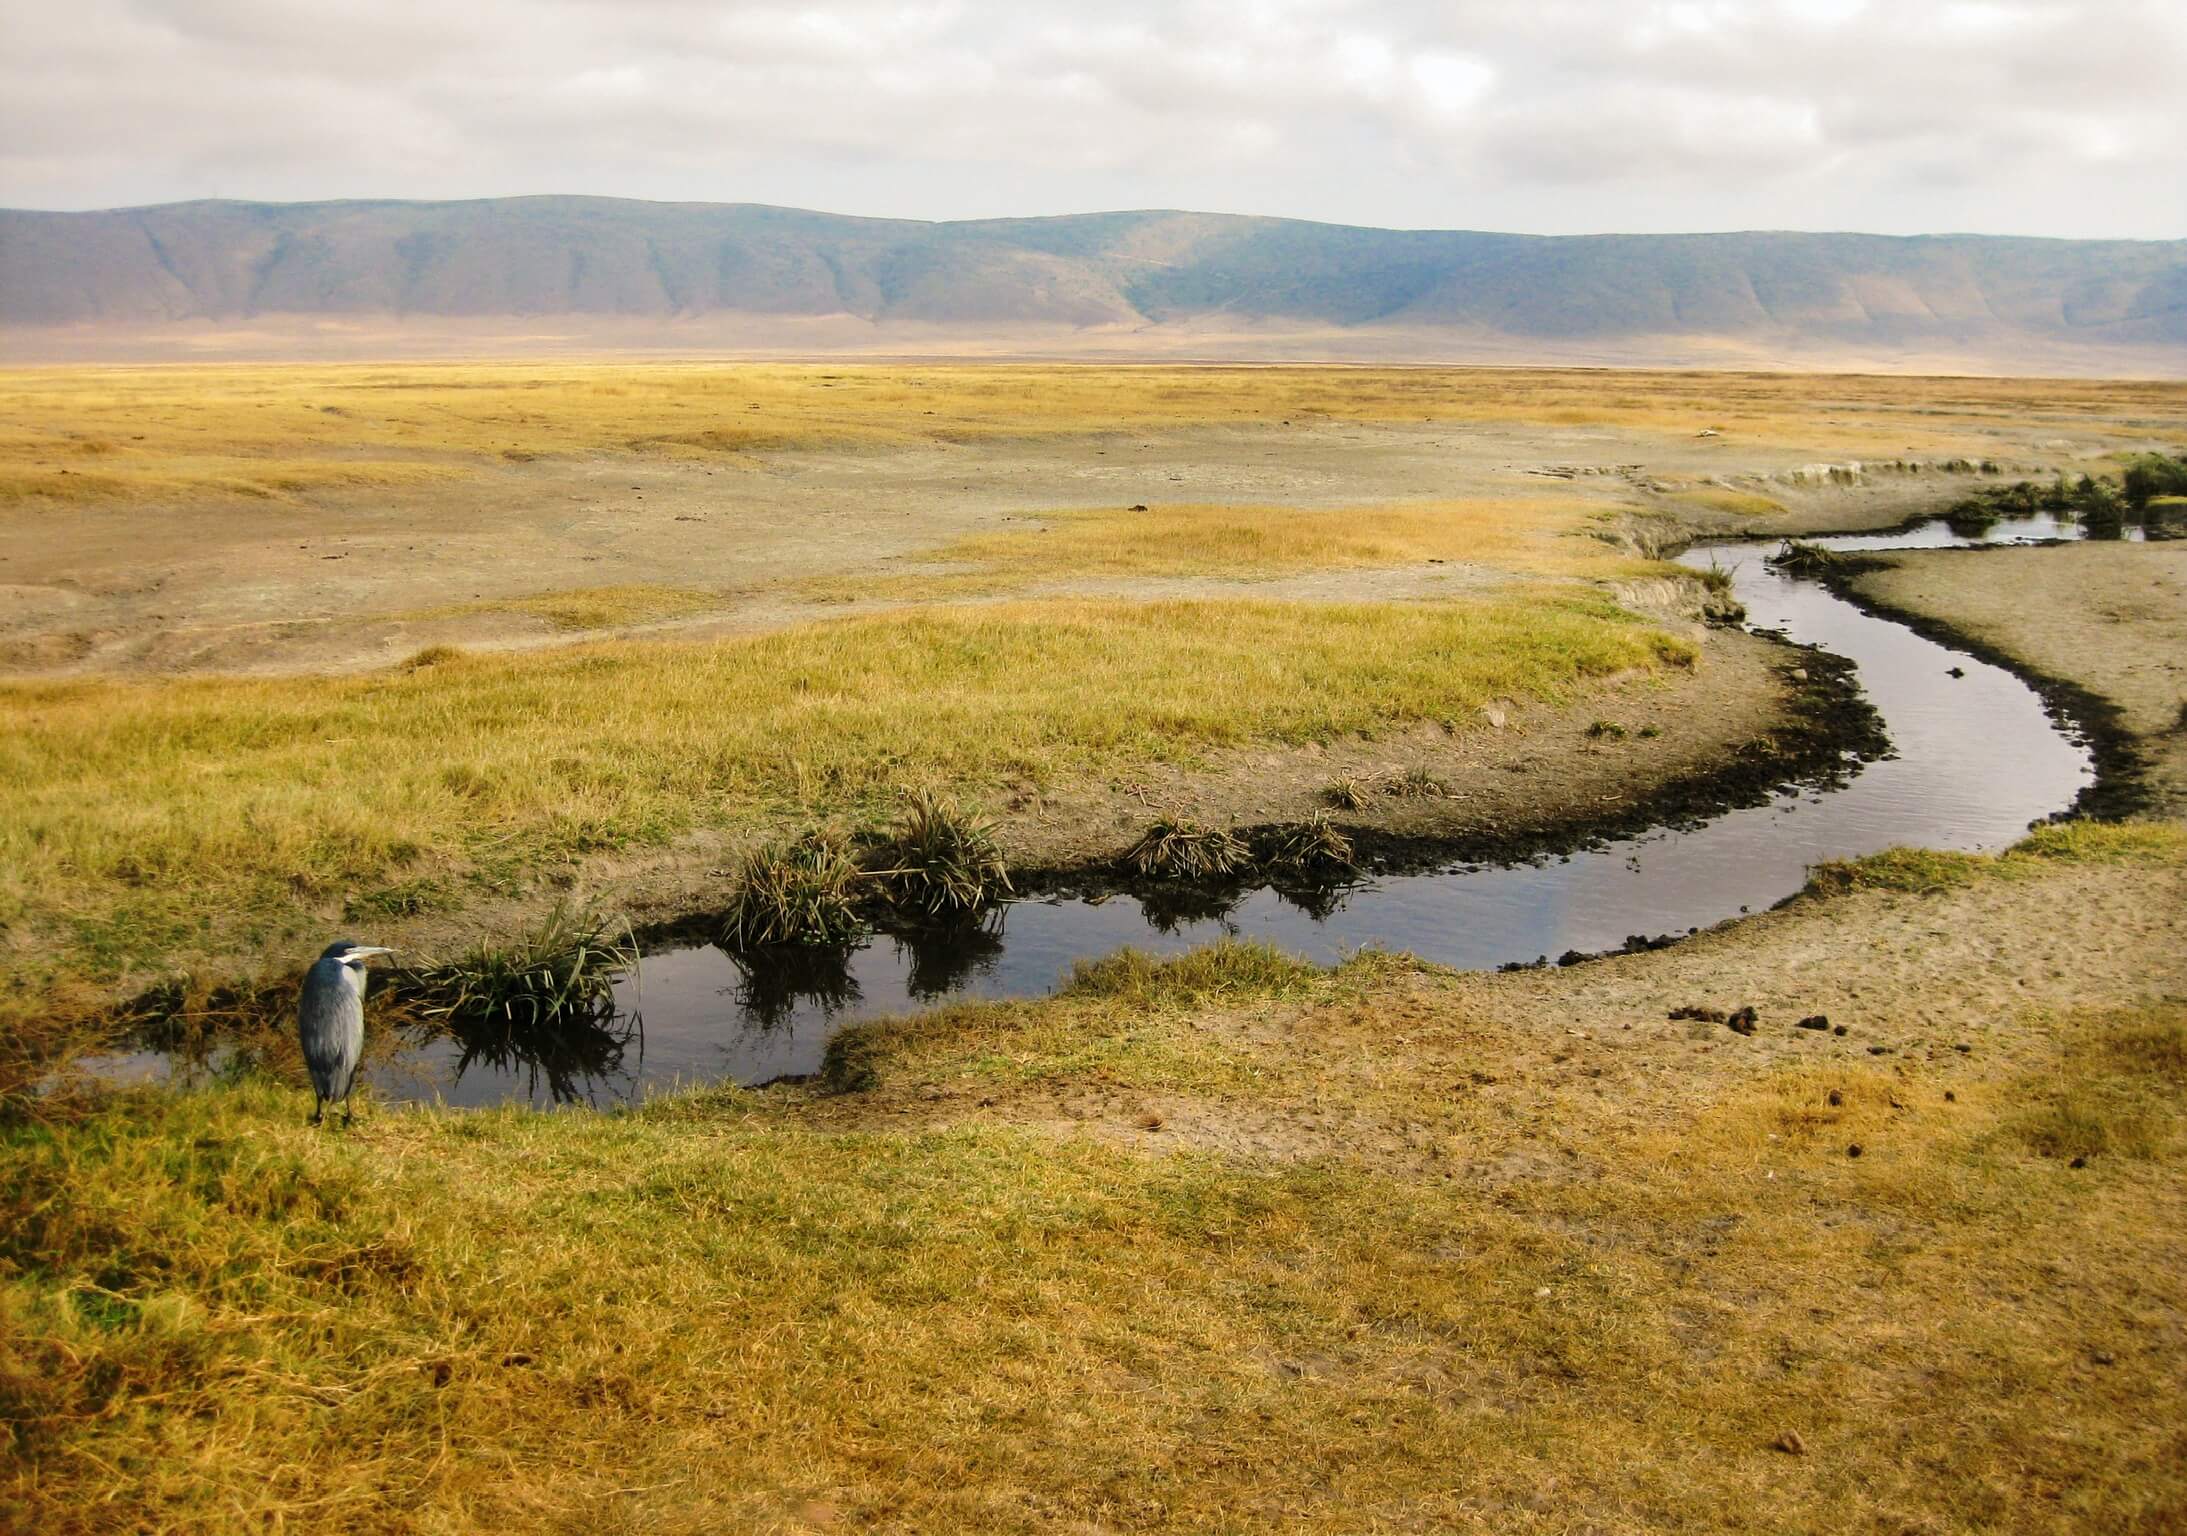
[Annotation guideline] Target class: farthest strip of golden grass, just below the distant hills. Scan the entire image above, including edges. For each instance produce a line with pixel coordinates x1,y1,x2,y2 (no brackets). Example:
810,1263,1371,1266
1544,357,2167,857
17,363,2187,505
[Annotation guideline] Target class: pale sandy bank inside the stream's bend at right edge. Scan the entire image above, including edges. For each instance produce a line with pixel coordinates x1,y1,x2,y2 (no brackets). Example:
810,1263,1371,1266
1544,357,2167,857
1855,543,2187,816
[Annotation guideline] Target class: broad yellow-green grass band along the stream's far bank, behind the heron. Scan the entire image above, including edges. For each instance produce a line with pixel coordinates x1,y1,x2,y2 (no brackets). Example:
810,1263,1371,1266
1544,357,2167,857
0,591,1695,993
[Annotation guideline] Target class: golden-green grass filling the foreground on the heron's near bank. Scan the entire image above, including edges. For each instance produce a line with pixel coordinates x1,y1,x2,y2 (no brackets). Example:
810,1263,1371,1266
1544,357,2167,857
0,829,2187,1536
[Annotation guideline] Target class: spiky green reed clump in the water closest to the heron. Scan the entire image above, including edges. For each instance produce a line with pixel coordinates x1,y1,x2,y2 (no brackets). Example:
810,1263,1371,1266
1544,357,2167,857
396,904,639,1028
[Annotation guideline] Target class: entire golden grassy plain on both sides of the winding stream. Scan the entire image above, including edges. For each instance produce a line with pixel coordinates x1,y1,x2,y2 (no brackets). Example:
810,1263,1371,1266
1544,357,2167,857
12,363,2187,1532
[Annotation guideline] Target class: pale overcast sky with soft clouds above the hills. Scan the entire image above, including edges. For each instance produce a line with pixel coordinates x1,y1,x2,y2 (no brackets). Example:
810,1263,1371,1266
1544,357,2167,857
0,0,2187,238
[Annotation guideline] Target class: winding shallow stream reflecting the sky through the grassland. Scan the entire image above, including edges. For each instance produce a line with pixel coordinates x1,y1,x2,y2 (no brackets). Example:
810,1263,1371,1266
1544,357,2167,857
106,516,2134,1105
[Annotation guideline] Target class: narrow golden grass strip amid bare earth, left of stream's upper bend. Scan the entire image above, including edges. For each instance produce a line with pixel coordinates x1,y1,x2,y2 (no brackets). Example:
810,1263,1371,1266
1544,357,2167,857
798,497,1666,600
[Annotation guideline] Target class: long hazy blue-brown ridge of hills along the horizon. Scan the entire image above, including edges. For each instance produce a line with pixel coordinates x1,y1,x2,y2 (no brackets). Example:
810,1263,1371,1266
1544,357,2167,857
0,197,2187,374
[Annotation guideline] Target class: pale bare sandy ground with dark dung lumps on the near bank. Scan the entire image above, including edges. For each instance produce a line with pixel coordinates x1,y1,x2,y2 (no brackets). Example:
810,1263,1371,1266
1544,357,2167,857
814,835,2187,1182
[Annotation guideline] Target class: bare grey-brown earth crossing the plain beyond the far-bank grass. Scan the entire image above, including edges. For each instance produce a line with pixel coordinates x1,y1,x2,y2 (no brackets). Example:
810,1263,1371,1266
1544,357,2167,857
0,422,2113,676
